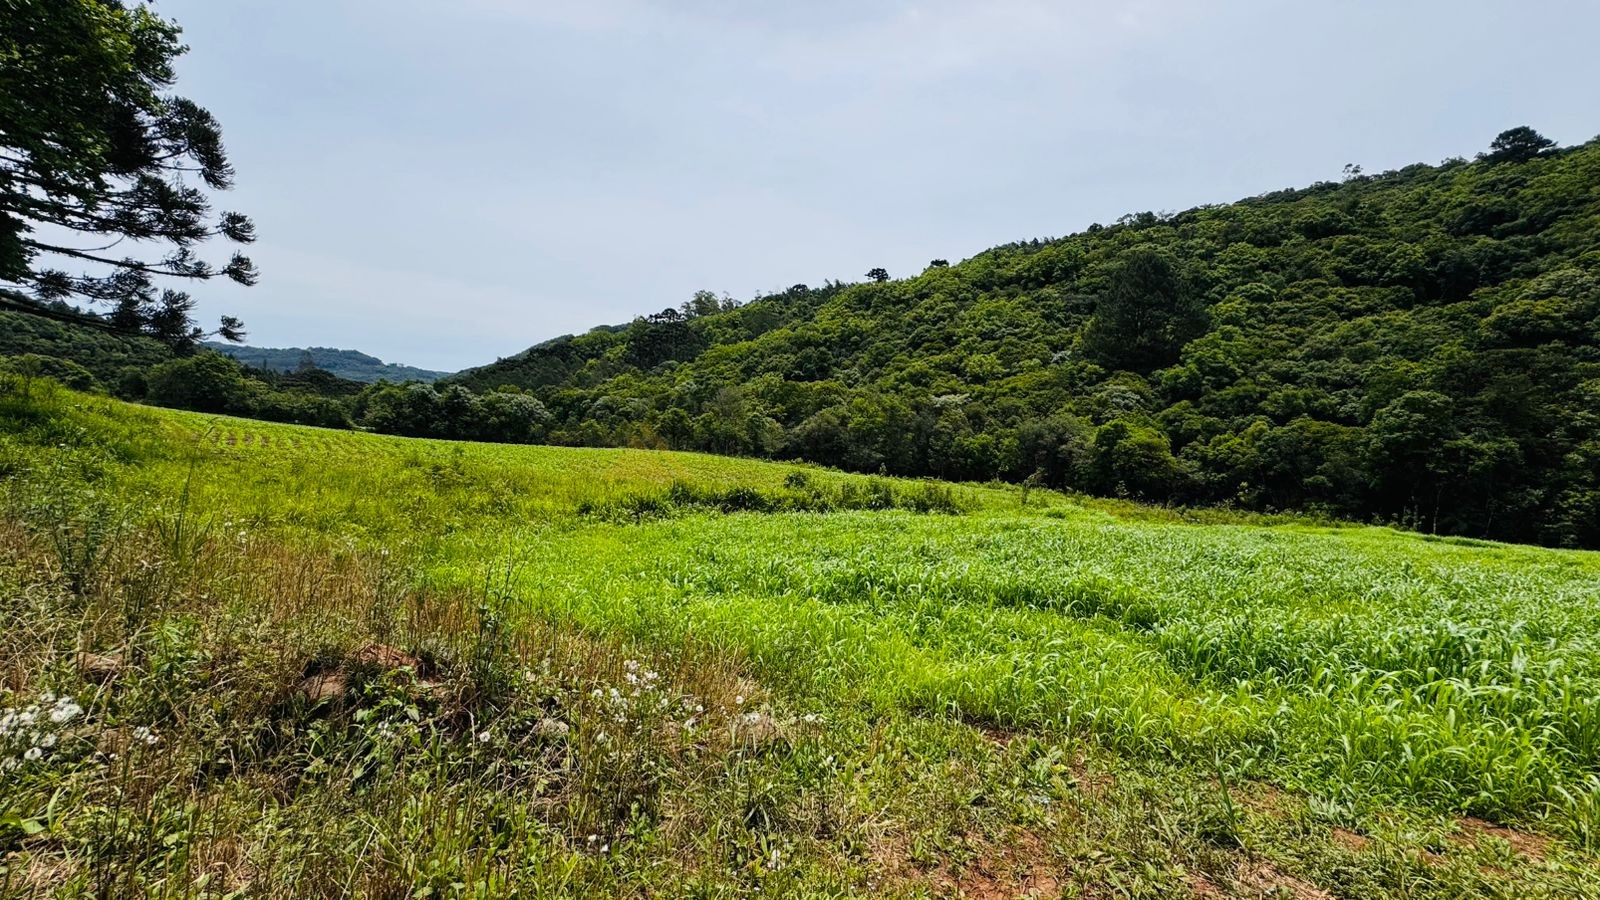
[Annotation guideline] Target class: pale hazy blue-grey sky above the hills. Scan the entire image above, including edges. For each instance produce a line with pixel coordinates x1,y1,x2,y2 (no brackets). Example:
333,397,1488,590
144,0,1600,370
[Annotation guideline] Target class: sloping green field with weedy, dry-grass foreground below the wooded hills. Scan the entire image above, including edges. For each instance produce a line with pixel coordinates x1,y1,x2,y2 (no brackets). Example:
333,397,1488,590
0,383,1600,898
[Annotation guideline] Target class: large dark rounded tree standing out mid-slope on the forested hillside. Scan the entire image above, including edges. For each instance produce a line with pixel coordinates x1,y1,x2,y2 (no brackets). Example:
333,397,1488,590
1083,248,1206,375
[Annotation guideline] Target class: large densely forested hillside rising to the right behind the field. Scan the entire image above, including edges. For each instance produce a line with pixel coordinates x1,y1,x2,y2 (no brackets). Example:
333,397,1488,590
451,128,1600,546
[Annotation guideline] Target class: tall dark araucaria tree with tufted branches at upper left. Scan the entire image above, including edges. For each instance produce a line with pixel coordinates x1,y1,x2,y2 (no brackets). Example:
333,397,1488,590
0,0,256,348
